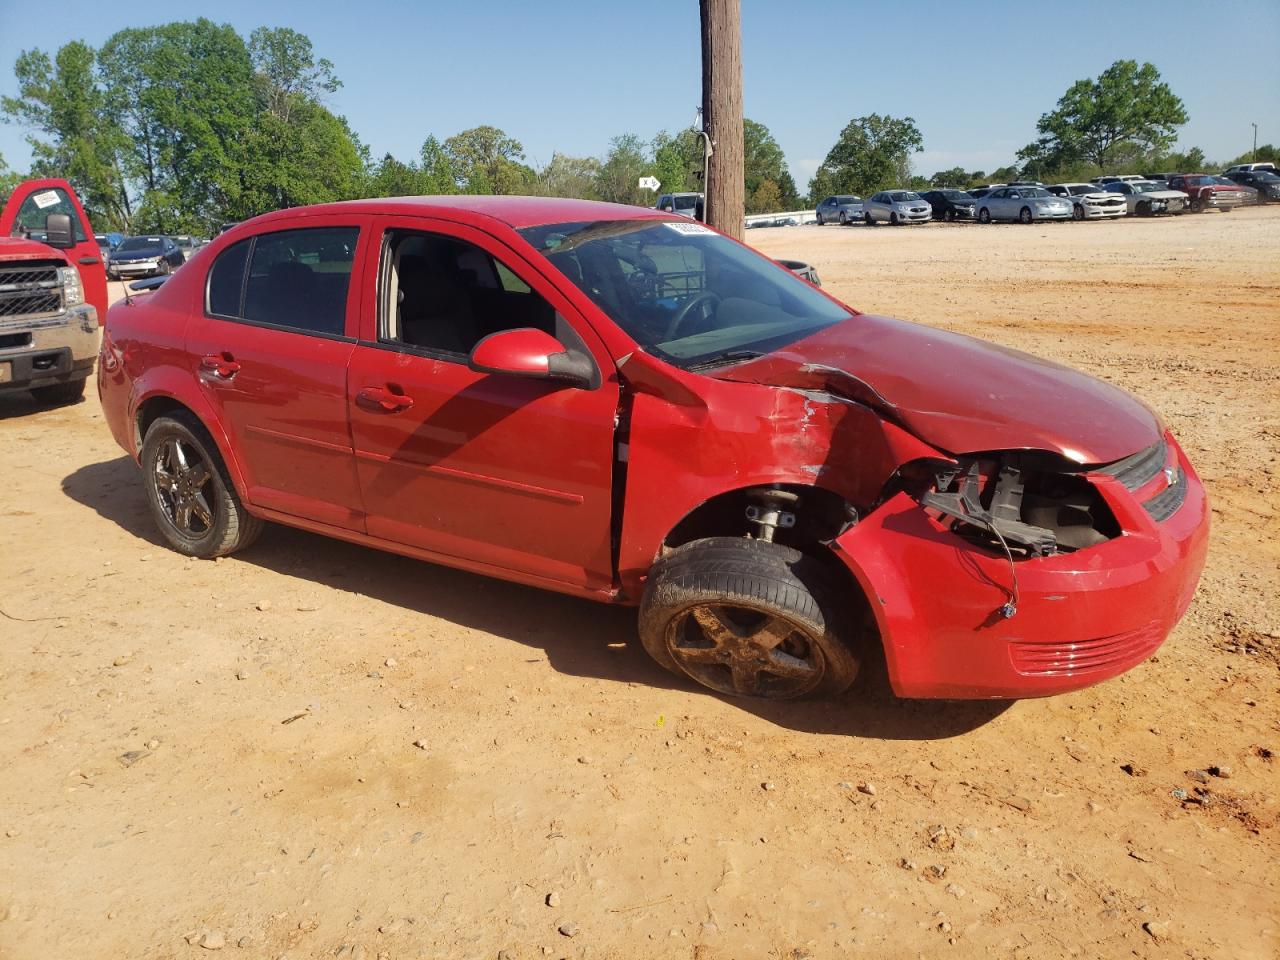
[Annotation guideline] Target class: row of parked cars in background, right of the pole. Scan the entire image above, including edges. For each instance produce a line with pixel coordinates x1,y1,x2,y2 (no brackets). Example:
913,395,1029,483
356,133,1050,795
814,164,1280,227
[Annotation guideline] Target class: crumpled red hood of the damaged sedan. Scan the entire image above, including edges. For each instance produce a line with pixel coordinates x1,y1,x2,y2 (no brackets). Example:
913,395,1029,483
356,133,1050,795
713,314,1162,463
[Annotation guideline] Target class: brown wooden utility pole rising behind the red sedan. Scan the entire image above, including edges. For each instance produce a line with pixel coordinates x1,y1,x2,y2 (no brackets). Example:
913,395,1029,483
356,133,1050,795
699,0,746,239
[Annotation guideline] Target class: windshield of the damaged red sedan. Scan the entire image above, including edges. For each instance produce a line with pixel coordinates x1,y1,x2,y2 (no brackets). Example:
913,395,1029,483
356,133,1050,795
520,220,851,367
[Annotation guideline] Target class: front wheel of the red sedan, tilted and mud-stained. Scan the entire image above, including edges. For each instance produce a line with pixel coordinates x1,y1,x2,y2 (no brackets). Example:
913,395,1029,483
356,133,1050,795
640,536,859,700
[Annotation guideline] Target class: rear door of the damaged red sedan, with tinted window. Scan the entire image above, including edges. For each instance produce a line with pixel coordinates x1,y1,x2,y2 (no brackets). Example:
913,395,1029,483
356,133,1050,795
187,215,369,531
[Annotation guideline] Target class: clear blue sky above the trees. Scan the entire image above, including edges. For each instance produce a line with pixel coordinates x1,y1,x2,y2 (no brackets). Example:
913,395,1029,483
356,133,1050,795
0,0,1280,189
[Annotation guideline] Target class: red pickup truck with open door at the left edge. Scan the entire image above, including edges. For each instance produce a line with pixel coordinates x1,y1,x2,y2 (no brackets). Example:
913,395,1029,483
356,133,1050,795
0,179,106,403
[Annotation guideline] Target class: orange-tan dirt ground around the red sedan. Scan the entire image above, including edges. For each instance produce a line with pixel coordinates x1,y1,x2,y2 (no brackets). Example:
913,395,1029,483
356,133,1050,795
0,207,1280,960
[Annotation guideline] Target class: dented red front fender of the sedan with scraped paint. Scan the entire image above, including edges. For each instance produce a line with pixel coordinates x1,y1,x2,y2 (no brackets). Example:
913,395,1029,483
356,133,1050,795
618,355,938,599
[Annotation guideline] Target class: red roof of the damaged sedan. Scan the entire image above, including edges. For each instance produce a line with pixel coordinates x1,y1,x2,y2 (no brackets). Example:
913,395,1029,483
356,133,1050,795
239,193,680,229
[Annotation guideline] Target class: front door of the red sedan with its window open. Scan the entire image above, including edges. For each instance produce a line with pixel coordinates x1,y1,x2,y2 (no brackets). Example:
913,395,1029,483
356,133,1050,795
348,216,618,591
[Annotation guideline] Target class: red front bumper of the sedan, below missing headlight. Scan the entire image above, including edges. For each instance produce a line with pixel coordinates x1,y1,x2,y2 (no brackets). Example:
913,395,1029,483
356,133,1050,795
835,438,1210,699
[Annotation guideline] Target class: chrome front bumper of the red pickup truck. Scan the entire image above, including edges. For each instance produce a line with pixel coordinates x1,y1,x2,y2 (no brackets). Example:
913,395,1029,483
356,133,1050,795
0,303,102,390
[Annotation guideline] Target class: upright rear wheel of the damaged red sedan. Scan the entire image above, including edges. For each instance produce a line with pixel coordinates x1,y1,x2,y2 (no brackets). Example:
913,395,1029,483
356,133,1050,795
141,413,262,559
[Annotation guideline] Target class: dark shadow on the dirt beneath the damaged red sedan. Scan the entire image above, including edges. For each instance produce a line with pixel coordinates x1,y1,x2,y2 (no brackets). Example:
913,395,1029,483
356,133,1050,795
63,457,1012,740
